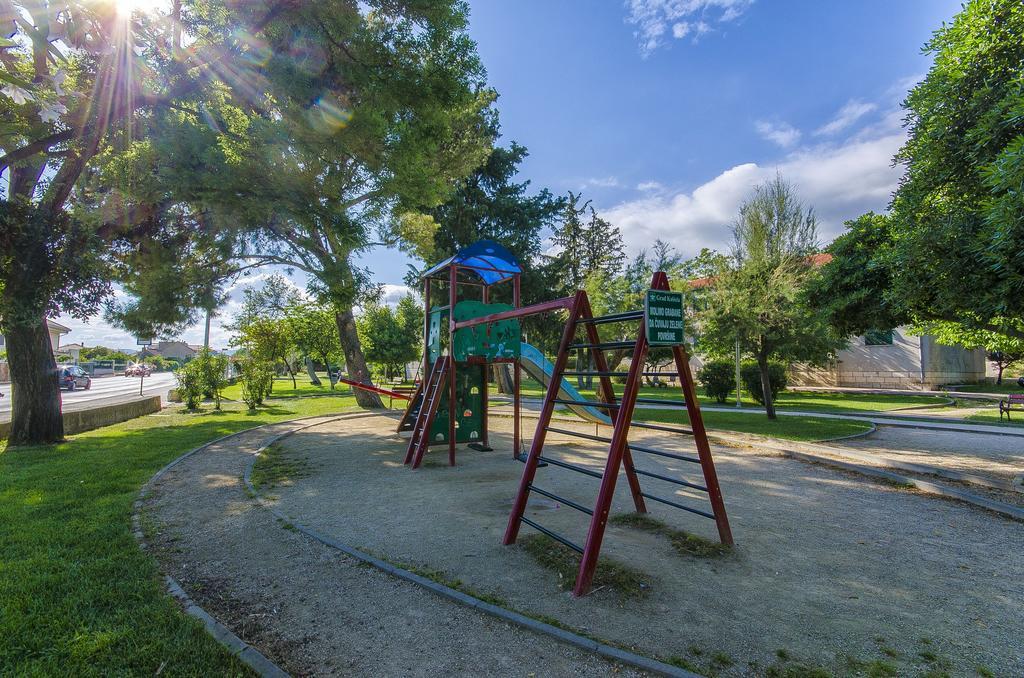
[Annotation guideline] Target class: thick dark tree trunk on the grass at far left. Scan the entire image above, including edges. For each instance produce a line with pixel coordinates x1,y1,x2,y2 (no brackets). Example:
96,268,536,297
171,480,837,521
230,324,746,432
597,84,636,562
6,319,63,446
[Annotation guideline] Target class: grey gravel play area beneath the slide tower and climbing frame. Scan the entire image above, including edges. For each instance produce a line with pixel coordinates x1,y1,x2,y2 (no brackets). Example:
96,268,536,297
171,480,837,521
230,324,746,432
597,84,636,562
272,418,1024,675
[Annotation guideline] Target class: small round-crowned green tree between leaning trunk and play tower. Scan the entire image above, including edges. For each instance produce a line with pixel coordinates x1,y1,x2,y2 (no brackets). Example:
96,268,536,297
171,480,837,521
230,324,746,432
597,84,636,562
358,295,423,379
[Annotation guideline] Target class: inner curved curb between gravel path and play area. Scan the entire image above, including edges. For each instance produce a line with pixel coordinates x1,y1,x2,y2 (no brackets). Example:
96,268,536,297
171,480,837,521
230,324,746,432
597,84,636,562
244,422,700,678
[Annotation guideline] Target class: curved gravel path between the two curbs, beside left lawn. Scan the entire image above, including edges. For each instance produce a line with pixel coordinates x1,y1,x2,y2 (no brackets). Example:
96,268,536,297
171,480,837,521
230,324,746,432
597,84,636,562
142,417,637,676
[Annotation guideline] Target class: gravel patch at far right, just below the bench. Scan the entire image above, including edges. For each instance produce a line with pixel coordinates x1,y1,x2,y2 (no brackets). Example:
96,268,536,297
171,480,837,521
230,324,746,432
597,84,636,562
828,426,1024,480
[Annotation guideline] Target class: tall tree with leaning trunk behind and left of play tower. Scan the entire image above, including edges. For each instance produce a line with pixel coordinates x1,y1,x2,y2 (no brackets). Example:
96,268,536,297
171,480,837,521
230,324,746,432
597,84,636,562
217,0,495,407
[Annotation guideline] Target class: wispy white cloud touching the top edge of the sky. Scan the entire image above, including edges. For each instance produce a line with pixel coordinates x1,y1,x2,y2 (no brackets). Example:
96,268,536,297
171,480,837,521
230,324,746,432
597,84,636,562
626,0,754,57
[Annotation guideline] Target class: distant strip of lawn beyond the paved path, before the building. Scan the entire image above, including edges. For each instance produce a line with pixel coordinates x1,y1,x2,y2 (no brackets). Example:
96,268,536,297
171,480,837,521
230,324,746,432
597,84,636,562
493,379,948,414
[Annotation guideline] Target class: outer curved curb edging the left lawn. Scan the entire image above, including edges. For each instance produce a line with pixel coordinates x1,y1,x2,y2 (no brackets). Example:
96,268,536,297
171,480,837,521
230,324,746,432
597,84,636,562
131,415,356,678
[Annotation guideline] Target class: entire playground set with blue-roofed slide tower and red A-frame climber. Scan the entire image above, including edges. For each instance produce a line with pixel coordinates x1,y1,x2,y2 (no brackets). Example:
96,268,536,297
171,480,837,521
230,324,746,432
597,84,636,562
398,241,733,596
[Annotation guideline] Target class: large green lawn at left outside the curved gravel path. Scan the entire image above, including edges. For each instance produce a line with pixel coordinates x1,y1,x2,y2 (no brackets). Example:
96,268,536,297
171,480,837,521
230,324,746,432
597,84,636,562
0,396,353,676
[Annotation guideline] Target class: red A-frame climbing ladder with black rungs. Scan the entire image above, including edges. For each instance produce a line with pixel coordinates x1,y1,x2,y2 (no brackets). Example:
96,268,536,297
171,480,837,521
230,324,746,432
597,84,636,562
504,272,732,596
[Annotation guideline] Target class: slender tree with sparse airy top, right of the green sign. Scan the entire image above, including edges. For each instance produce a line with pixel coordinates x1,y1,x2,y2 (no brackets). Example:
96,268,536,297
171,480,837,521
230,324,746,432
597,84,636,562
697,176,843,419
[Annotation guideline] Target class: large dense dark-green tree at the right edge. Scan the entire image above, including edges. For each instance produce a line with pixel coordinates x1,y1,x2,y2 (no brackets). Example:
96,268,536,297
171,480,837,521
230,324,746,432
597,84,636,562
806,0,1024,346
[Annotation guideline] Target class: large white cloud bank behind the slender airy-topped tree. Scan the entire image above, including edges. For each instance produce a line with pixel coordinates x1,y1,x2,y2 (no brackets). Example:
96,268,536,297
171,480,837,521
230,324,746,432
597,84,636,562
602,125,905,256
